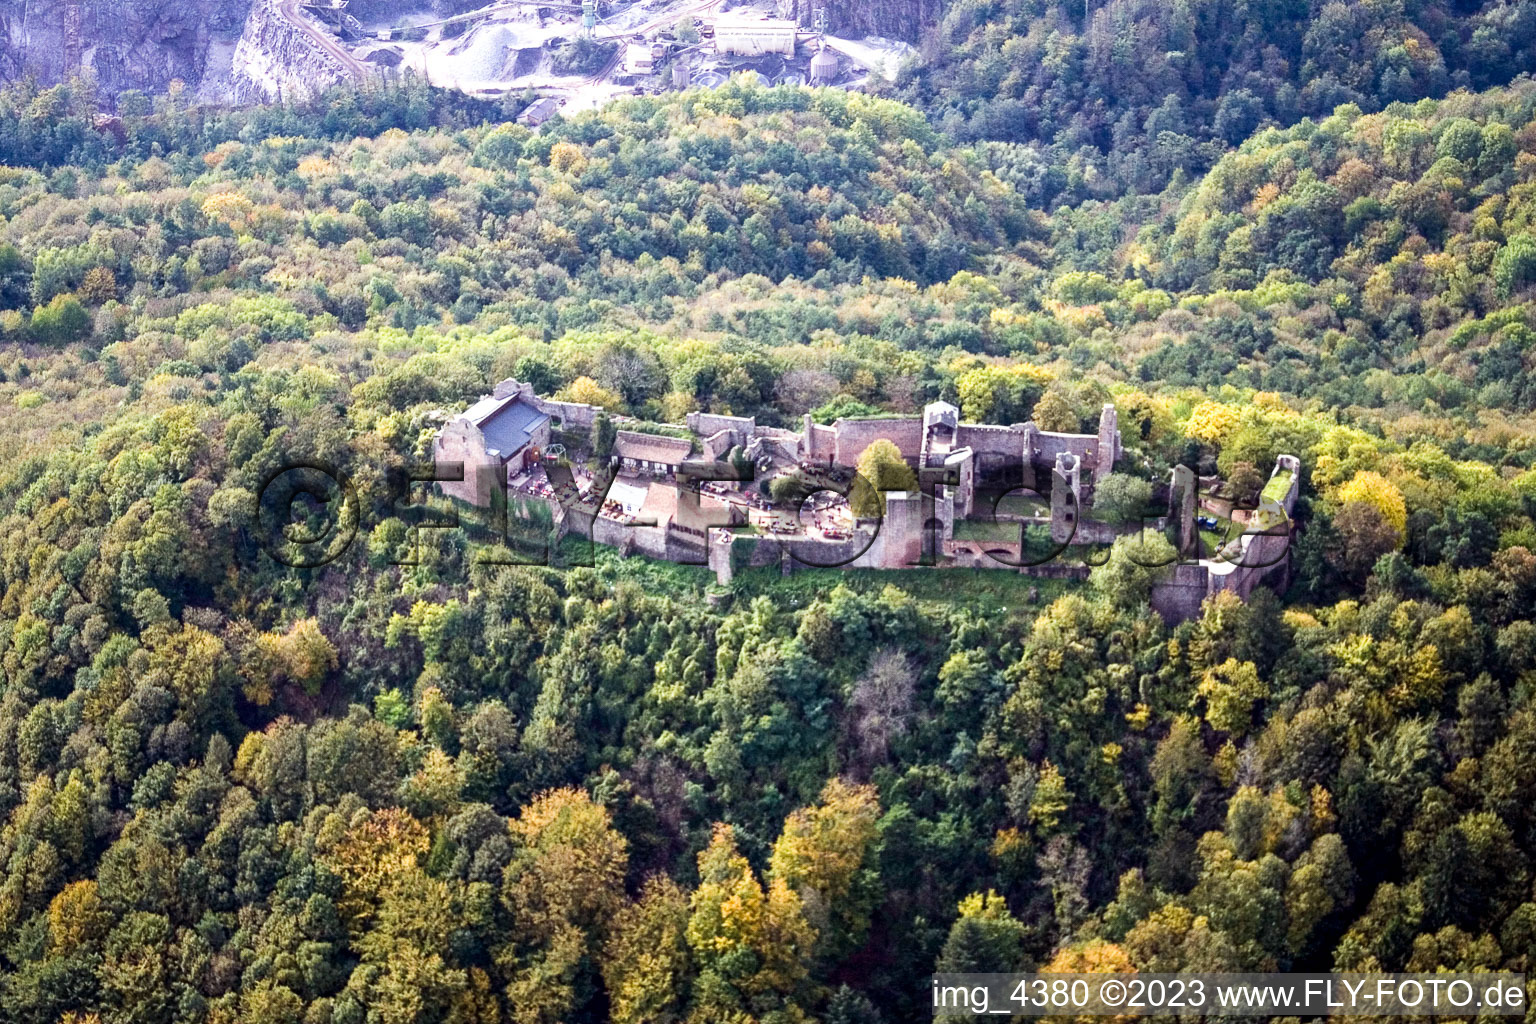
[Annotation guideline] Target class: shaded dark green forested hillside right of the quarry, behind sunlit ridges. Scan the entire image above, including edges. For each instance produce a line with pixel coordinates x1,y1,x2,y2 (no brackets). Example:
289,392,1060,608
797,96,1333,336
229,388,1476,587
900,0,1536,206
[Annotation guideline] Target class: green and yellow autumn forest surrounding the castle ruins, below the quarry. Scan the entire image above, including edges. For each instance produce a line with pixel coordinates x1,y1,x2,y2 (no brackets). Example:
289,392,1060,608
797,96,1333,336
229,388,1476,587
0,0,1536,1024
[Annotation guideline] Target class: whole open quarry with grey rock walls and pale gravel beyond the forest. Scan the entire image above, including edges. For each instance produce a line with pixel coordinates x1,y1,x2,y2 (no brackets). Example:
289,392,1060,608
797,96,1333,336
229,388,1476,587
0,0,937,114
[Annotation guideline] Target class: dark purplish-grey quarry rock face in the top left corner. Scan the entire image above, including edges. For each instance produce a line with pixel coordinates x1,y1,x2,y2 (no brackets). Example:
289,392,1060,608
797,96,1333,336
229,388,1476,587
0,0,252,103
